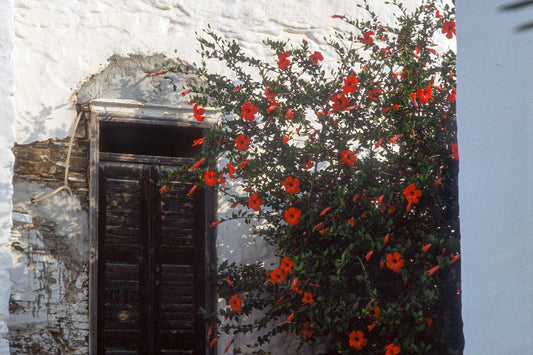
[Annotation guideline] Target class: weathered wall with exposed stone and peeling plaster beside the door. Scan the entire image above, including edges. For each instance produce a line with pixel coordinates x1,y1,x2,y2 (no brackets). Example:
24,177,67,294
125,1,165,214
8,116,89,354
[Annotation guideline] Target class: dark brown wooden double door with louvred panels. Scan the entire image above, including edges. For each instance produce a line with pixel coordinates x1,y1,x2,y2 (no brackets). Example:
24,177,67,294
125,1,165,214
97,154,206,355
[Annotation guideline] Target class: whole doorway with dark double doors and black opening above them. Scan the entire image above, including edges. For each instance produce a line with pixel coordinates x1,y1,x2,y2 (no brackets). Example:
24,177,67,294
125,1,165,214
90,101,214,355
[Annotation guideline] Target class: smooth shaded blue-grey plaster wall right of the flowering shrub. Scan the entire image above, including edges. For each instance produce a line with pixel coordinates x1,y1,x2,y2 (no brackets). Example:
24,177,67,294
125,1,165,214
456,0,533,355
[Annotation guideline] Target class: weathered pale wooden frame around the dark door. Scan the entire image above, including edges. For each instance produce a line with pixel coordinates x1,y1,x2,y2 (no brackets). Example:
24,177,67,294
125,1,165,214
89,100,220,355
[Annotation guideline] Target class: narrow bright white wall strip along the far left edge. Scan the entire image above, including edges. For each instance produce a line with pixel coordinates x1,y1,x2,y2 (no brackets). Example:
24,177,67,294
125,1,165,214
0,0,15,354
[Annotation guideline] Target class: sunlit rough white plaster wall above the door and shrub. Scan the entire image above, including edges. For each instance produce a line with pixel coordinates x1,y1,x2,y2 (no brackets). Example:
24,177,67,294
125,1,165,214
15,0,432,143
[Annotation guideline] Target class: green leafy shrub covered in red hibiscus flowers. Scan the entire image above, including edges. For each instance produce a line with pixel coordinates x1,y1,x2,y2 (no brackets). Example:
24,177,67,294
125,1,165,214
167,2,462,355
